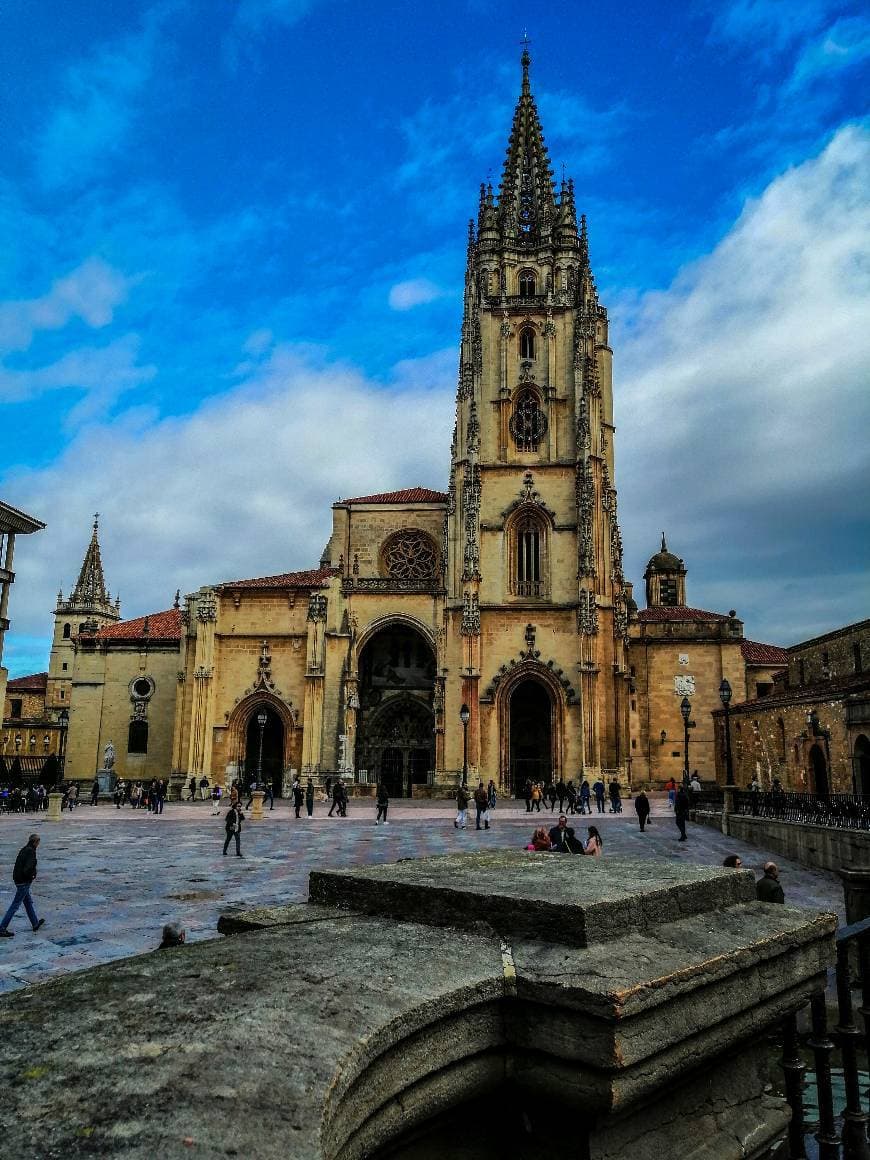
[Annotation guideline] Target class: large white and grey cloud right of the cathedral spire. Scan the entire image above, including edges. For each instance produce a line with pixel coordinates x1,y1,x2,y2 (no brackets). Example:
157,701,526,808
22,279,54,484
614,125,870,639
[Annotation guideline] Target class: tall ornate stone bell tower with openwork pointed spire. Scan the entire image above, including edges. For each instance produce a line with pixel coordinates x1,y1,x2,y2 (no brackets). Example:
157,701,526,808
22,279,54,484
444,51,628,791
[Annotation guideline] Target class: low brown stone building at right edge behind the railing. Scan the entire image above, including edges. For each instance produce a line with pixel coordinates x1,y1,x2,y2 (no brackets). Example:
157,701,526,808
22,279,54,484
713,621,870,793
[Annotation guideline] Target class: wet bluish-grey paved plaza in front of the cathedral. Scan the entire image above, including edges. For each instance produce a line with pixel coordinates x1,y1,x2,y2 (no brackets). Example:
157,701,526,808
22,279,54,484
0,800,844,993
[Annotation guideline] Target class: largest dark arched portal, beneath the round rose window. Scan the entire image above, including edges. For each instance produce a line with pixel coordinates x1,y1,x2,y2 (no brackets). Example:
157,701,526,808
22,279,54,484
356,624,435,797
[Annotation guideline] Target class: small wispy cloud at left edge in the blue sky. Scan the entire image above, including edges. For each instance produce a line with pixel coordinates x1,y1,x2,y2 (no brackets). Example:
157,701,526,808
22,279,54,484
0,258,131,353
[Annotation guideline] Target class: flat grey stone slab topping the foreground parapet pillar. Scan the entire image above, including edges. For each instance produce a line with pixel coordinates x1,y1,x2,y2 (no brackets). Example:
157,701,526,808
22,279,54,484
309,850,755,947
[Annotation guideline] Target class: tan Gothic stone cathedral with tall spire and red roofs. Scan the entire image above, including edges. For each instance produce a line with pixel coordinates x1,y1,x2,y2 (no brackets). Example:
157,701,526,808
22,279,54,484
1,52,781,796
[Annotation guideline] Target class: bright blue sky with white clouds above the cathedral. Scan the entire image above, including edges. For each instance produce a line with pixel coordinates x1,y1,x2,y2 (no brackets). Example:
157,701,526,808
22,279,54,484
0,0,870,676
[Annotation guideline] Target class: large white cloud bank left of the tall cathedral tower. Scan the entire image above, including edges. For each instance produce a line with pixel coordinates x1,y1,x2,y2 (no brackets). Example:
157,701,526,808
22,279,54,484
1,346,455,662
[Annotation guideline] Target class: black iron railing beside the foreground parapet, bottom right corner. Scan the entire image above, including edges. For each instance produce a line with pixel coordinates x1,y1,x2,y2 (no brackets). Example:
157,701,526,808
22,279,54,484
783,919,870,1160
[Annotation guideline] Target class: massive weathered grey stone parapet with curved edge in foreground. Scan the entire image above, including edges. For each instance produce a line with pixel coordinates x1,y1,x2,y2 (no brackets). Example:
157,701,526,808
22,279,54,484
0,855,835,1160
